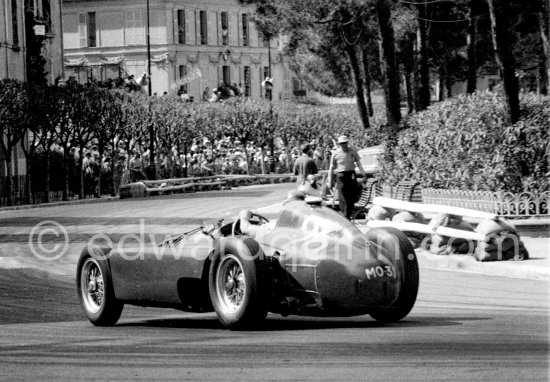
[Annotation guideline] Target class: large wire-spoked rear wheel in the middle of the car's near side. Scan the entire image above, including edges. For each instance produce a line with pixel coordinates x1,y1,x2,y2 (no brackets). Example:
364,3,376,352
208,238,269,329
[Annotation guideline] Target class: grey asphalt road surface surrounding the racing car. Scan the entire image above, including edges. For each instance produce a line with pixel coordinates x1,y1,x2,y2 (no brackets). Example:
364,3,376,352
0,186,550,381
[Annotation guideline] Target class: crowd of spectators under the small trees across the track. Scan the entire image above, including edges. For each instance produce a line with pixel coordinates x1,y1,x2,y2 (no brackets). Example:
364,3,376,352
60,137,333,197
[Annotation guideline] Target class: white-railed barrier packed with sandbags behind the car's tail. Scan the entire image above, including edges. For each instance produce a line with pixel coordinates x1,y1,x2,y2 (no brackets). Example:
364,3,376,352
366,197,529,261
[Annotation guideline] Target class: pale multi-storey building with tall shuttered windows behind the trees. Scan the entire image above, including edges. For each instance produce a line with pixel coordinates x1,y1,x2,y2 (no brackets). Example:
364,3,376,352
63,0,304,100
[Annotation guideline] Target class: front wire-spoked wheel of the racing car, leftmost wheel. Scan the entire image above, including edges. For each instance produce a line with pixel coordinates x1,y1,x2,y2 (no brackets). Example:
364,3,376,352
76,249,124,326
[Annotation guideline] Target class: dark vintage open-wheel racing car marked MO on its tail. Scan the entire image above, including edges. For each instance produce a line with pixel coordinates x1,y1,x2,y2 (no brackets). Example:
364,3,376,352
76,198,419,328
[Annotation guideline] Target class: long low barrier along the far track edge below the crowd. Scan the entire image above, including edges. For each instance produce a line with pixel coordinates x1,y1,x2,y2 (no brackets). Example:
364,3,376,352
120,174,296,199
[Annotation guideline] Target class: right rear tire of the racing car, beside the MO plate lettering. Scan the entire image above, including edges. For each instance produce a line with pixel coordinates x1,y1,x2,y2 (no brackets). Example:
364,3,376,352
367,227,419,323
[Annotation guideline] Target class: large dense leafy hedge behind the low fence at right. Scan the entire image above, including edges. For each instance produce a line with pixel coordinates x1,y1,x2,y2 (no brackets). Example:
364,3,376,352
381,92,550,192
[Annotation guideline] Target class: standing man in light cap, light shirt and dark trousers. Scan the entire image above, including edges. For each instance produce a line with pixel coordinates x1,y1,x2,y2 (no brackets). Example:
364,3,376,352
328,135,365,219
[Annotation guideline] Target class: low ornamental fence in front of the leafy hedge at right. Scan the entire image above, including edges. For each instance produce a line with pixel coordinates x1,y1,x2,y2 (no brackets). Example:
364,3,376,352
421,188,550,218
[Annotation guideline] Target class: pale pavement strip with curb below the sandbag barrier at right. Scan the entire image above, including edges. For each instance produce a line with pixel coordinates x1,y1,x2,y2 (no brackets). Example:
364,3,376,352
416,249,550,280
